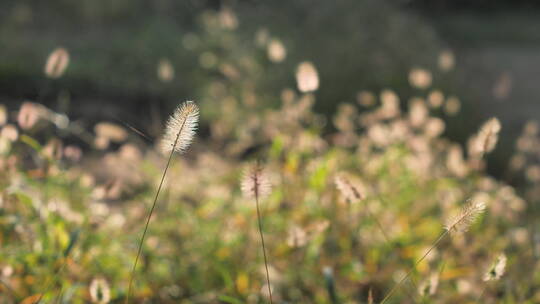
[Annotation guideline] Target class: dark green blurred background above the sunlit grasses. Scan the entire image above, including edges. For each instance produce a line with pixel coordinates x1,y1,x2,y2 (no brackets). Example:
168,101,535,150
0,0,540,175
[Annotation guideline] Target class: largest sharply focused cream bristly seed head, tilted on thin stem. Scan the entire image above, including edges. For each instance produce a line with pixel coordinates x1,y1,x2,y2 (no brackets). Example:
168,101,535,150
161,101,199,153
